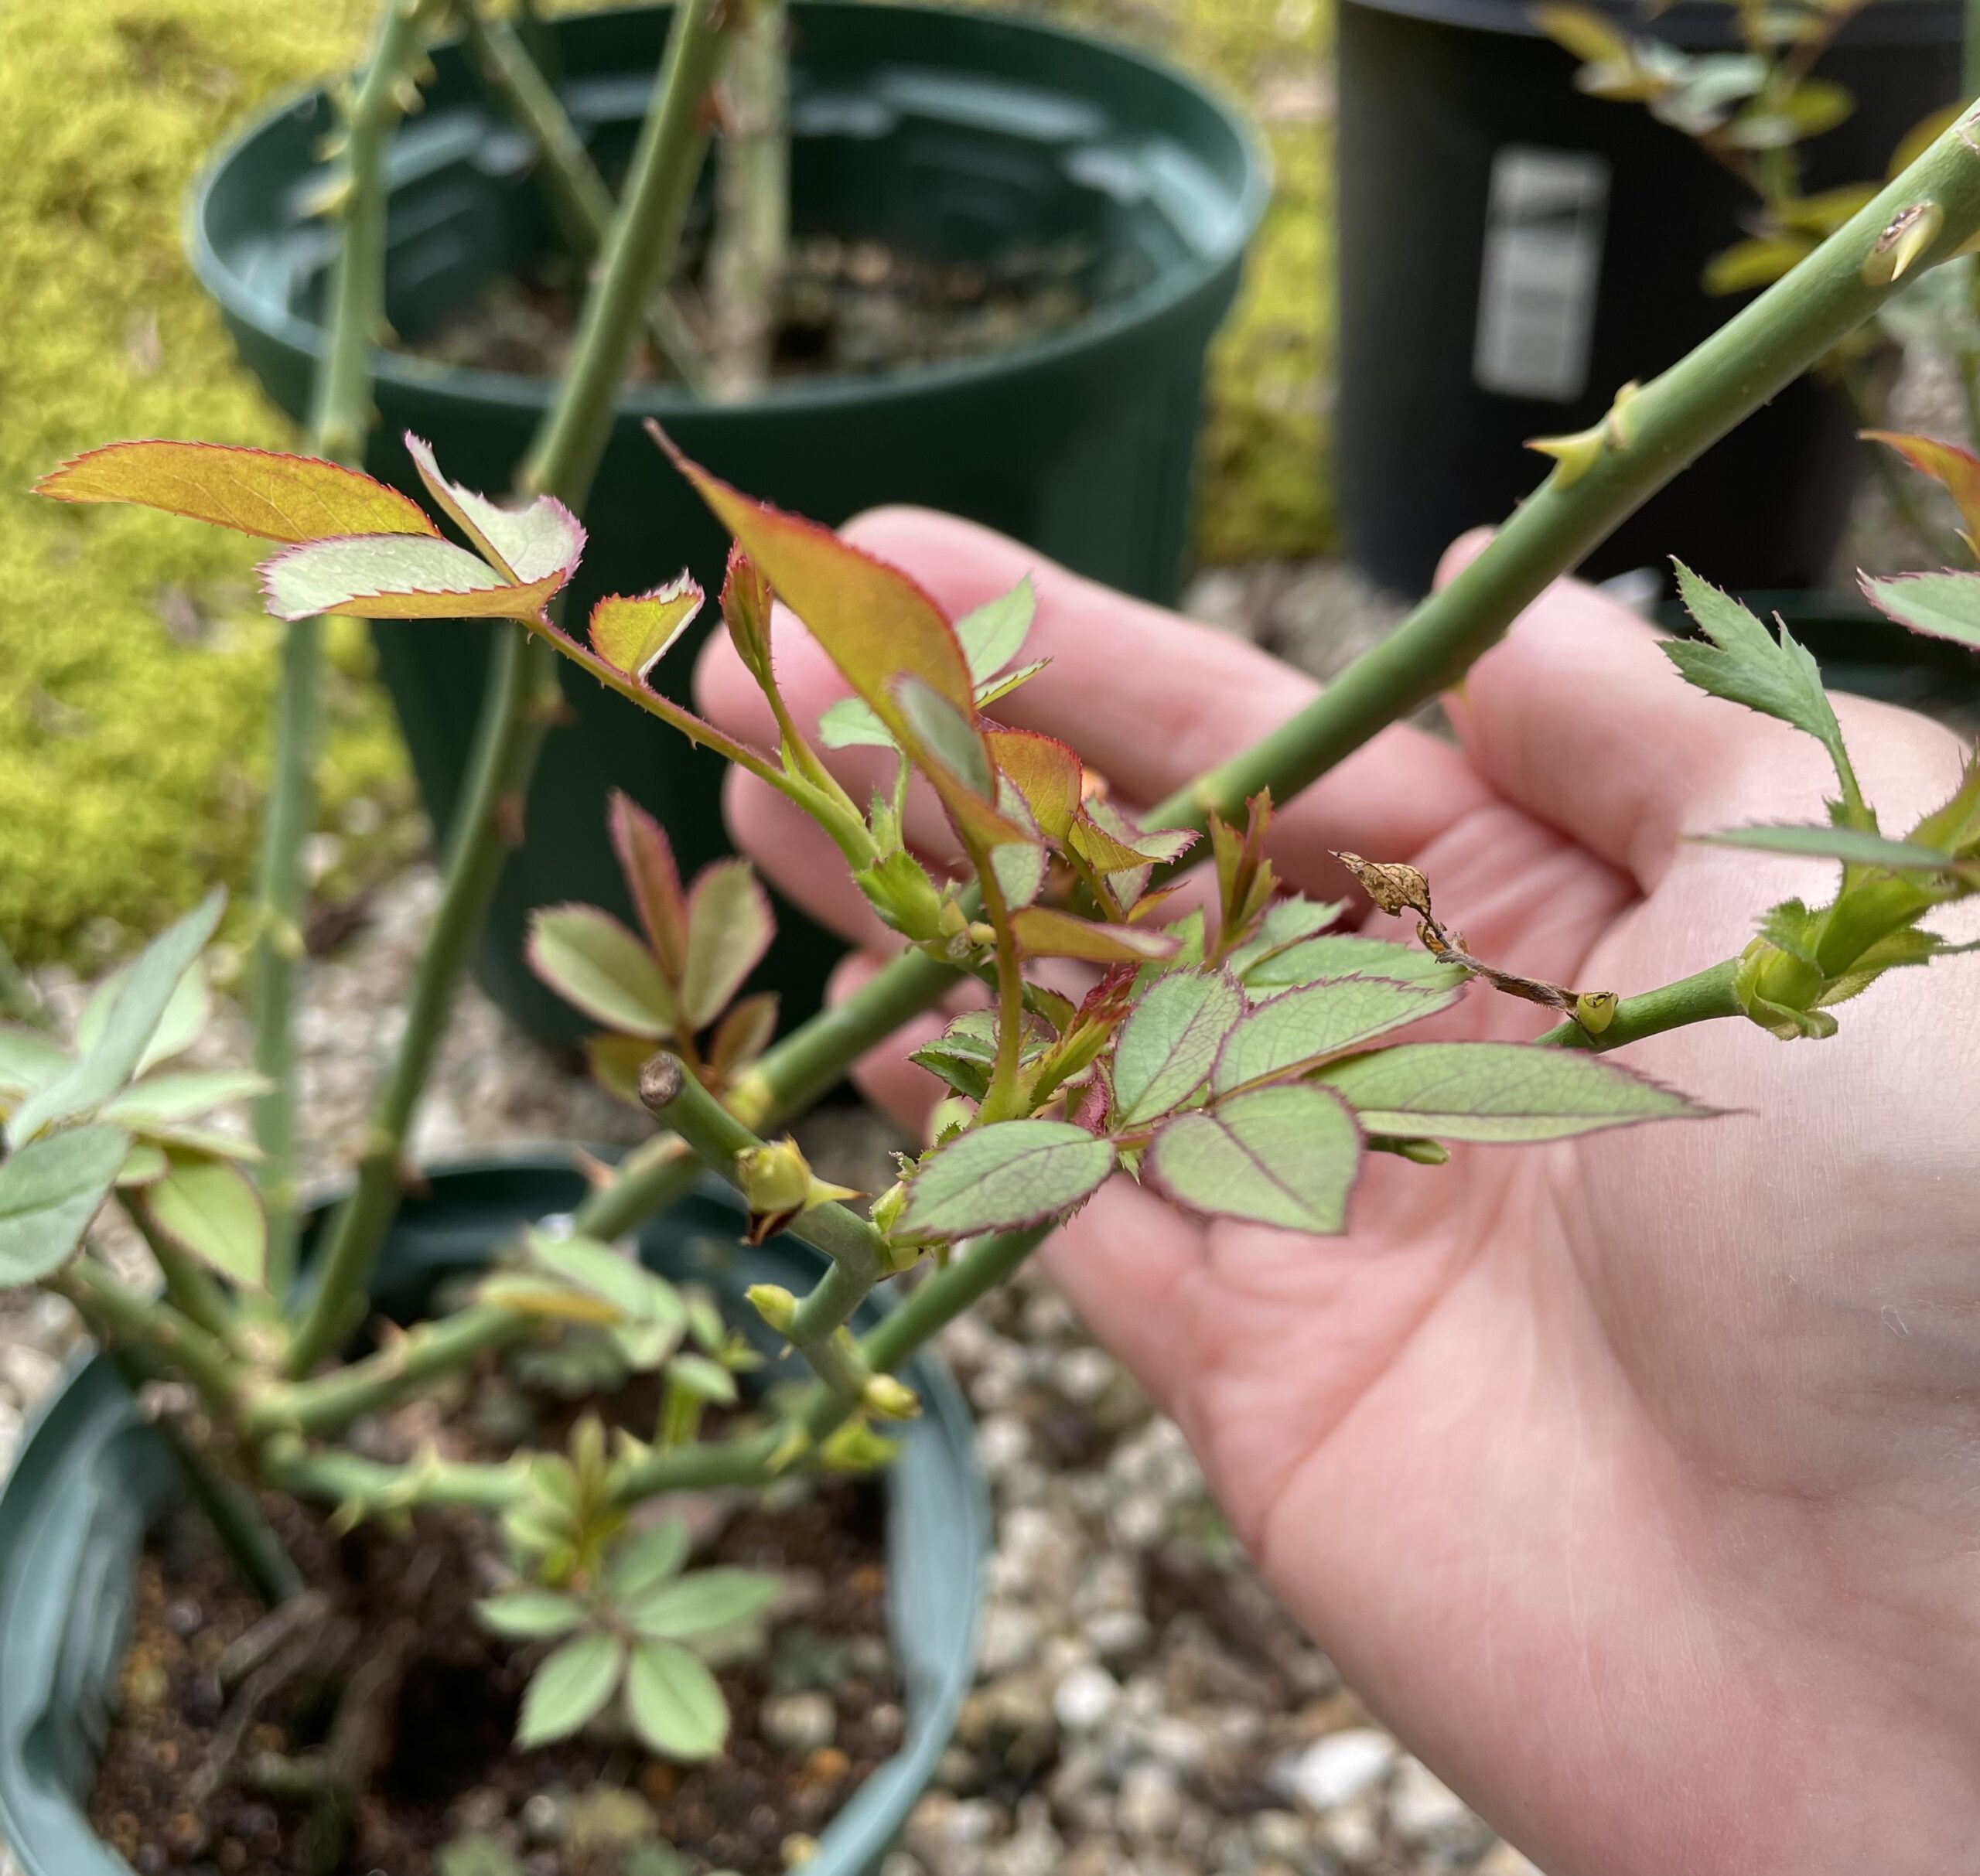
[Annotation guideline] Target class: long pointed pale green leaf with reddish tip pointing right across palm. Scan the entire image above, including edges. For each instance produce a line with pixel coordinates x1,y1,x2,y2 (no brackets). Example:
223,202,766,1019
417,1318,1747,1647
1321,1043,1712,1142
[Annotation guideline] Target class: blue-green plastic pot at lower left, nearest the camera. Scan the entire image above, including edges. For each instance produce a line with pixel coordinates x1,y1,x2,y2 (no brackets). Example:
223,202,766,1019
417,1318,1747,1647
0,1155,990,1876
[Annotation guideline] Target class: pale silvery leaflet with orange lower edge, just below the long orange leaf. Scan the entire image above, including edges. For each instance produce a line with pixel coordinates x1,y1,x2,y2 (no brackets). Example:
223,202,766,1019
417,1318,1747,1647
258,534,570,619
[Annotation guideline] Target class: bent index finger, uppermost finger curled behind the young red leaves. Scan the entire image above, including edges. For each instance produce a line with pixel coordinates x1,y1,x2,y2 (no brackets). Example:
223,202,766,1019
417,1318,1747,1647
699,509,1487,891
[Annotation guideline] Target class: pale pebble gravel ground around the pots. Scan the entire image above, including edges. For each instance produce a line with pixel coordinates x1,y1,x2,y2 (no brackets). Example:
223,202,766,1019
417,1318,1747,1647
0,564,1568,1876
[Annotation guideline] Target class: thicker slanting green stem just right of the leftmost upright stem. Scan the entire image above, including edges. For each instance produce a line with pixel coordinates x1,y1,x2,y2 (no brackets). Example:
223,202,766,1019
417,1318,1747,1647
289,0,727,1376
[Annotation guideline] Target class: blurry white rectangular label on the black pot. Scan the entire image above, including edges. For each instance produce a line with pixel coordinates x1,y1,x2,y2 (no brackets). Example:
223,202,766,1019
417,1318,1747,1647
1471,145,1610,404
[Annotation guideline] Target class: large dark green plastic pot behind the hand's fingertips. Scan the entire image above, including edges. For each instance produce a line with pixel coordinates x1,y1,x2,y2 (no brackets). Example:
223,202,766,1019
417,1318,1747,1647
190,0,1267,1041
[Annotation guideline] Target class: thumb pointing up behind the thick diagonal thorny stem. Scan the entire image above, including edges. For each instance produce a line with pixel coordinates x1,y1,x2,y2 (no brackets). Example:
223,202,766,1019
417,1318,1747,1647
1438,532,1954,892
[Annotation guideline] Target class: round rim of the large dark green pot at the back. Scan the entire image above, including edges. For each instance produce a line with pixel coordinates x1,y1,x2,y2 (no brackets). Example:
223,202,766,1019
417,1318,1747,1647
184,0,1267,424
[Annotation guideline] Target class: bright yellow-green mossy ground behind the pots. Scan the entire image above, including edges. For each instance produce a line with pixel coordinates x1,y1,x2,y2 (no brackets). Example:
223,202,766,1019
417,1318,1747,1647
0,0,1330,962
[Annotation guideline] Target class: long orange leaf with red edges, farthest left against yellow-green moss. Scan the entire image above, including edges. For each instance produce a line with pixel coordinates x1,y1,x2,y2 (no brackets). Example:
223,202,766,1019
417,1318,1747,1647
34,439,439,542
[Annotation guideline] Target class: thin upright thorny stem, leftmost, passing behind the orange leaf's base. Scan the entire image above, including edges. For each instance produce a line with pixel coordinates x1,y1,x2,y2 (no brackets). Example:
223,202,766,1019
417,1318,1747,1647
254,0,443,1298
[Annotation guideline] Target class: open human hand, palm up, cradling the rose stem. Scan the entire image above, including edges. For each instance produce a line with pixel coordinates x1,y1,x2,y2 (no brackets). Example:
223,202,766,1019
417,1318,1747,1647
701,510,1980,1876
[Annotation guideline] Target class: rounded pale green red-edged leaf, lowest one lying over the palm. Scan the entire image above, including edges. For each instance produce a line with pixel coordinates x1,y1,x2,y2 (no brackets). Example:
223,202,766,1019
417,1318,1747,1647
1141,1083,1360,1236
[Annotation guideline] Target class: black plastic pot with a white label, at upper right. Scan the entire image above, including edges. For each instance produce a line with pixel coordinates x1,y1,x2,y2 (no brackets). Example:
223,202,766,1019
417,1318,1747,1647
1336,0,1960,594
